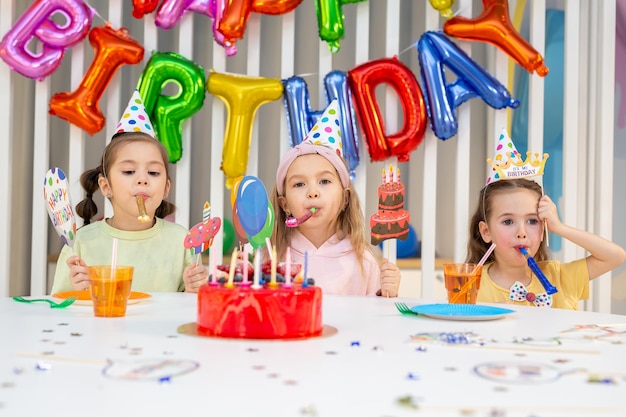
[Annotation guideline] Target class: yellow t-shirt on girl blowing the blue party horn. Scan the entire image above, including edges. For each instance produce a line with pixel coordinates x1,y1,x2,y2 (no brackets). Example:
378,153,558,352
477,259,589,310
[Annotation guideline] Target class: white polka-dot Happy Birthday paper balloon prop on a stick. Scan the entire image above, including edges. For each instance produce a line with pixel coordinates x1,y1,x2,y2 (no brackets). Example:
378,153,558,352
43,168,76,247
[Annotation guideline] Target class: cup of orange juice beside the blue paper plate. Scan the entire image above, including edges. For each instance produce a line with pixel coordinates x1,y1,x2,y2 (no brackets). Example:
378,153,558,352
443,263,483,304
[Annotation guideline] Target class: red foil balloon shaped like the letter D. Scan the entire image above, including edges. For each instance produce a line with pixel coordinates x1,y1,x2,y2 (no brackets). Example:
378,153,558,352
348,57,426,162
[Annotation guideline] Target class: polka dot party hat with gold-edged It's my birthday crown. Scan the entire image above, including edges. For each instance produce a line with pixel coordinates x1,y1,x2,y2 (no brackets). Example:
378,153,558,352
487,129,549,184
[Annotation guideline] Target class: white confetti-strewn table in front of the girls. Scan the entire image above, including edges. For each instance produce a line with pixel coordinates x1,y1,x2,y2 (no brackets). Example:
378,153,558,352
0,293,626,417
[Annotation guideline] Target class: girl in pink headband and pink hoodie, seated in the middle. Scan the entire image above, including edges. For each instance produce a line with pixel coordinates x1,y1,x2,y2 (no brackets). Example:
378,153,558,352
272,101,400,297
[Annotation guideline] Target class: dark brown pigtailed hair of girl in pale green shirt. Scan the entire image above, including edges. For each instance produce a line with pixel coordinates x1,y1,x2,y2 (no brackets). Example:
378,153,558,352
76,132,176,225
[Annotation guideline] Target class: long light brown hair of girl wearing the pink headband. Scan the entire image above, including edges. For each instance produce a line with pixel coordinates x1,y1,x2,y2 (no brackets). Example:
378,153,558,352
272,176,372,271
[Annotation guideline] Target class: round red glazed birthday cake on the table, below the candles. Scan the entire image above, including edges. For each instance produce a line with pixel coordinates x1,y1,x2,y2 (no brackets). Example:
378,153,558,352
197,260,322,339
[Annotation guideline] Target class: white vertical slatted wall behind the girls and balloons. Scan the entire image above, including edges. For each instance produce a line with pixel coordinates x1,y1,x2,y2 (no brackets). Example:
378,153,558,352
0,0,615,311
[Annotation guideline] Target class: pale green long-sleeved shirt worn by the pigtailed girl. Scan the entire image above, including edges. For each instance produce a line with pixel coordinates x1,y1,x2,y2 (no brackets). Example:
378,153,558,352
52,218,195,294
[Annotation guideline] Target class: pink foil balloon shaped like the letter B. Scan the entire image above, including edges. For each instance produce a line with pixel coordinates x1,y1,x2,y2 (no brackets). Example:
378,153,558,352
0,0,93,81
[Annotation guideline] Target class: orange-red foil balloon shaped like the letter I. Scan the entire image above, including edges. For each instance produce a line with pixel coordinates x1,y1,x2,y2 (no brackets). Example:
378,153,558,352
50,24,144,135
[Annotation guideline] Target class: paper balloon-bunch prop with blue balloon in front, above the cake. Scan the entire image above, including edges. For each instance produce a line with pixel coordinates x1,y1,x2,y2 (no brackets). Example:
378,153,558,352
231,176,274,249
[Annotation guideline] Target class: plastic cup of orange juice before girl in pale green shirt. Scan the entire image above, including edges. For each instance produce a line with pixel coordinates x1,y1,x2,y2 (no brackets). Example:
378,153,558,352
88,265,134,317
